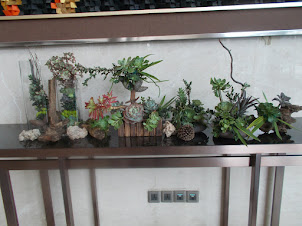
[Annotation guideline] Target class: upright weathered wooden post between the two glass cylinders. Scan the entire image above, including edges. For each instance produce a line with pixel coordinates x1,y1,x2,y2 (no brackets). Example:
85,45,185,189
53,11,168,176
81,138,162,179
48,78,59,125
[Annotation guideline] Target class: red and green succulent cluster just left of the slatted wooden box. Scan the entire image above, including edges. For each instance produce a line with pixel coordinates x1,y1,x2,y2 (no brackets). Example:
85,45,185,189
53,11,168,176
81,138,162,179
85,91,123,140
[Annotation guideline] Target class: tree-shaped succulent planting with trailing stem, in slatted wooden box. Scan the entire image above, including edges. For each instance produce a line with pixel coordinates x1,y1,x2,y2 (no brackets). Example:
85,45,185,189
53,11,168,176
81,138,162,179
78,55,168,136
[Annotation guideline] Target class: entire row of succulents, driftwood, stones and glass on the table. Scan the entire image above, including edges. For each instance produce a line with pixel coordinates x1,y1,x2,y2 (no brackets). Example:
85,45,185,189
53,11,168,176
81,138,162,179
19,40,302,145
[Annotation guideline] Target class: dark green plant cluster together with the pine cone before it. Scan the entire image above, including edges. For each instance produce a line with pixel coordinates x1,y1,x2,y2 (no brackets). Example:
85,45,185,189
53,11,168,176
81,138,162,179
171,80,207,141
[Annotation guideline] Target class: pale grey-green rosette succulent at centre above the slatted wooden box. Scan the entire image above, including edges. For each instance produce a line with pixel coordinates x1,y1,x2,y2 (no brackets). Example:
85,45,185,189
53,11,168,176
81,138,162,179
124,103,144,124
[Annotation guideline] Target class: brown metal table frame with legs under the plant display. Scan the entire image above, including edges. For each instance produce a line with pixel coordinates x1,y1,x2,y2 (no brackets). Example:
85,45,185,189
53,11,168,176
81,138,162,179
0,144,302,226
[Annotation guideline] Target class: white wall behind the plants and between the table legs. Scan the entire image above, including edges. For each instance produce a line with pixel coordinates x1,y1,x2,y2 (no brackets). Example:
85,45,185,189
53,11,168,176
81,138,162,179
0,36,302,226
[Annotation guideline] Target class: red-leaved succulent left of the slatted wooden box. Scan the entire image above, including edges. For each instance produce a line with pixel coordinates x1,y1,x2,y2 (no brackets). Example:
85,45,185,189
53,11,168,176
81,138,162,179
85,91,117,120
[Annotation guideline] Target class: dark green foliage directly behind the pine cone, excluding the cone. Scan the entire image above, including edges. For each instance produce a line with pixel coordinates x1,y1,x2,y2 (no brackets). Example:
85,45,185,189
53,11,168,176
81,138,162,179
172,80,206,129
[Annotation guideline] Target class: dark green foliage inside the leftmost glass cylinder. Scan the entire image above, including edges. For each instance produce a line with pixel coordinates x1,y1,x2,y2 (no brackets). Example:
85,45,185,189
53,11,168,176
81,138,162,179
28,75,48,120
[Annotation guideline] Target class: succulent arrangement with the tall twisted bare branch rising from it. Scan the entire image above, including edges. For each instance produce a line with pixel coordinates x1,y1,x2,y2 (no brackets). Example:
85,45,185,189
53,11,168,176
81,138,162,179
210,40,259,145
